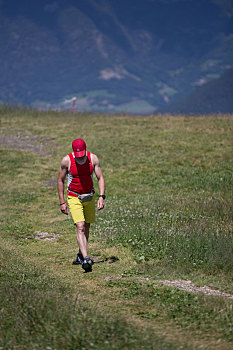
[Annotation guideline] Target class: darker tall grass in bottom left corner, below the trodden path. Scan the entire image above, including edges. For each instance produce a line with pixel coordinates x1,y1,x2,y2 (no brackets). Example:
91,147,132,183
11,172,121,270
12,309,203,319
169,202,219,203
0,246,173,350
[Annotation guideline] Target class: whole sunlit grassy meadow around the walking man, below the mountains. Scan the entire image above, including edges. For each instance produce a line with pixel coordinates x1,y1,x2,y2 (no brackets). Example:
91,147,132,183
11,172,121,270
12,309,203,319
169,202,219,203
0,106,233,350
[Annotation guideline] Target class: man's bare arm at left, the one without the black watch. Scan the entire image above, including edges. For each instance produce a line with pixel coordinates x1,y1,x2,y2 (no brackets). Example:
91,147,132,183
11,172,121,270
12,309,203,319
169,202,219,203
57,156,69,215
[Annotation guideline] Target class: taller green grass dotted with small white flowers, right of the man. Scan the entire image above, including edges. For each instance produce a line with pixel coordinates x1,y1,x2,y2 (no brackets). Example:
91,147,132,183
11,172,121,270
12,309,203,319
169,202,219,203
95,194,233,273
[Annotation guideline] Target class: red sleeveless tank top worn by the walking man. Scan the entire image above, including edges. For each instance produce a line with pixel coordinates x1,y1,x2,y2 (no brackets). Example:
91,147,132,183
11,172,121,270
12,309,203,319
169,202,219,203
67,152,95,197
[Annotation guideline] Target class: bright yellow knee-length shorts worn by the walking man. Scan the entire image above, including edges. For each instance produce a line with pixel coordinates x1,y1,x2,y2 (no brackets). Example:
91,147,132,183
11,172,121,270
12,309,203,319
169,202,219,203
68,196,95,224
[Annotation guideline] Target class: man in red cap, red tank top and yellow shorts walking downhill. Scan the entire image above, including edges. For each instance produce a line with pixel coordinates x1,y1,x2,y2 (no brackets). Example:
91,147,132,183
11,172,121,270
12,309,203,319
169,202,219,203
57,139,105,272
